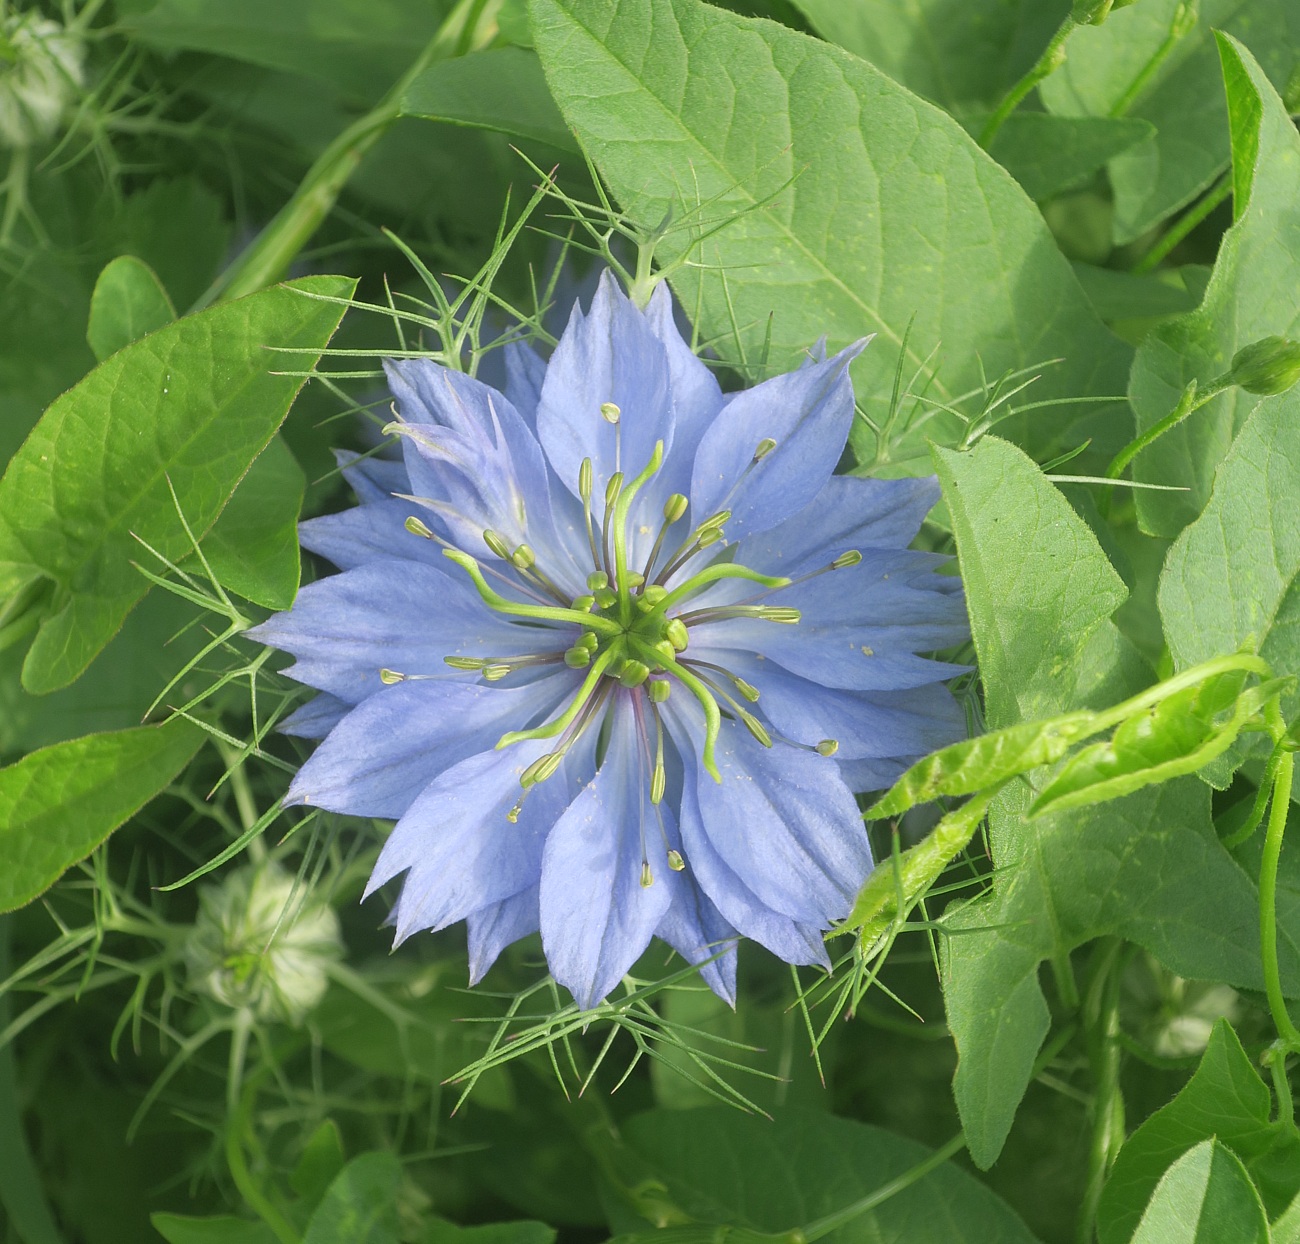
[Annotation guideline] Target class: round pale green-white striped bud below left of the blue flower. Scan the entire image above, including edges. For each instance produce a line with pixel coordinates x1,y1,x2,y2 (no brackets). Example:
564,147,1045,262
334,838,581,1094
183,863,343,1024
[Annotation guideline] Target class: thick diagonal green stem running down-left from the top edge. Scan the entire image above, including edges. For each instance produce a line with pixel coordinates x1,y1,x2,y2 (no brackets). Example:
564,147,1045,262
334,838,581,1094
191,0,488,311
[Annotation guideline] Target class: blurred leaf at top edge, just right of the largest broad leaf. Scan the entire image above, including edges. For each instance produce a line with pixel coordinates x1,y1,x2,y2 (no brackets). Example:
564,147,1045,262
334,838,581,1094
794,0,1070,113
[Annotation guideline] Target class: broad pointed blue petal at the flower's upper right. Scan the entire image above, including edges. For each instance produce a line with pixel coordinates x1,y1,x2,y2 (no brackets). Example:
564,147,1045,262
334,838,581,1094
690,341,866,539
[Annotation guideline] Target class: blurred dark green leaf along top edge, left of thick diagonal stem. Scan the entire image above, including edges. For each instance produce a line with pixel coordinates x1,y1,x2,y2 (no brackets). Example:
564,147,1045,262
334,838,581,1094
124,0,450,99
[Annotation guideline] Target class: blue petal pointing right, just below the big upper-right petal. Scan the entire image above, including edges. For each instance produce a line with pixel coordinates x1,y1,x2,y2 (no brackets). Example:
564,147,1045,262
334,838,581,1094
736,476,939,578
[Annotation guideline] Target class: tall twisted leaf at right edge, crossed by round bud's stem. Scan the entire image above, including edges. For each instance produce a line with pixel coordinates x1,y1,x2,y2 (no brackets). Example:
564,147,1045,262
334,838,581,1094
1130,36,1300,537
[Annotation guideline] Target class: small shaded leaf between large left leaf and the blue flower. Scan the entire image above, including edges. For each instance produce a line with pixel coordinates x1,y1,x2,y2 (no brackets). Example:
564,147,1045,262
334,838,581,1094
203,437,307,610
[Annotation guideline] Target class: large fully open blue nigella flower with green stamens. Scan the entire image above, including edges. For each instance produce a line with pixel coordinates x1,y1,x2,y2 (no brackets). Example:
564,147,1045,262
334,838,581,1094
255,274,966,1007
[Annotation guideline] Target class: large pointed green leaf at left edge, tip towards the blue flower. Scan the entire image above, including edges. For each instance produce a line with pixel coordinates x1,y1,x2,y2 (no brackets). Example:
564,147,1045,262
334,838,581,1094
0,277,352,694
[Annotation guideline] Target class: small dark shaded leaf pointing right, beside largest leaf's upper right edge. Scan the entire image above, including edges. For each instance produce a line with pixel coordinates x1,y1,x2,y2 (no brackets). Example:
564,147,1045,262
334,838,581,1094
989,112,1156,201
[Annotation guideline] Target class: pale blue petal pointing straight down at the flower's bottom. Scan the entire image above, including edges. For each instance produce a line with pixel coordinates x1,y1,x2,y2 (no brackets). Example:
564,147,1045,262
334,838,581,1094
541,695,675,1010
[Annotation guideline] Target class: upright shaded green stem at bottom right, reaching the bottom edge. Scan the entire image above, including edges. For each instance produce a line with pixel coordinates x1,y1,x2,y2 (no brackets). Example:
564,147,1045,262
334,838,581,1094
1076,939,1126,1244
